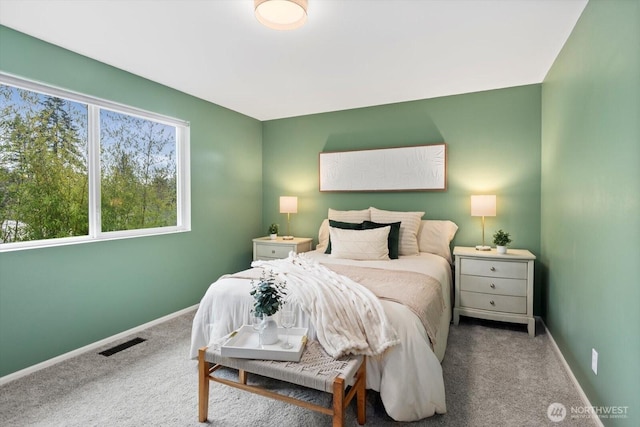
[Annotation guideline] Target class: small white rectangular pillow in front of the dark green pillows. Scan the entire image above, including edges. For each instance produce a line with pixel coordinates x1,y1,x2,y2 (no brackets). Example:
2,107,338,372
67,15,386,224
329,226,391,260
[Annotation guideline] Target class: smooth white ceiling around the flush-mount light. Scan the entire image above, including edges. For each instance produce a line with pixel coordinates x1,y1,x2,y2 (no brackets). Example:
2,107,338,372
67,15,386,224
0,0,587,120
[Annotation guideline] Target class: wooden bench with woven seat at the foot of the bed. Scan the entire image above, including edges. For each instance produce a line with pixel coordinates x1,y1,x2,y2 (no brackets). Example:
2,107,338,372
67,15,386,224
198,341,366,427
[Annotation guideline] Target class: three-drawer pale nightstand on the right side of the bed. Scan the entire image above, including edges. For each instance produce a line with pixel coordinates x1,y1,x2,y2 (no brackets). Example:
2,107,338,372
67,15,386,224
453,246,536,337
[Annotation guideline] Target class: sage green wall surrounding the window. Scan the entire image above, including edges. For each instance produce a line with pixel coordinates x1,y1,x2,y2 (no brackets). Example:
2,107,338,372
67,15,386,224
0,26,262,376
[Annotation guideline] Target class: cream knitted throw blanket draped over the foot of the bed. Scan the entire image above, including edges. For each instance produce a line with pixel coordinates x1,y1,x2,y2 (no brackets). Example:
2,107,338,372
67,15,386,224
251,254,400,358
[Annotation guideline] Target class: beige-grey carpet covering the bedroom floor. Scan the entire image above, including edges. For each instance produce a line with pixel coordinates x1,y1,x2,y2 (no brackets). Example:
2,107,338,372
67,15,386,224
0,313,595,427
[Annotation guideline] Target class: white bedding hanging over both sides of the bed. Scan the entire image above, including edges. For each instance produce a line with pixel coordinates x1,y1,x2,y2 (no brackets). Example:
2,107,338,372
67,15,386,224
190,251,452,421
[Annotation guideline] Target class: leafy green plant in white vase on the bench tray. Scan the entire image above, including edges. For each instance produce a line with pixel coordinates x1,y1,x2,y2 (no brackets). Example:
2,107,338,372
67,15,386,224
249,270,286,344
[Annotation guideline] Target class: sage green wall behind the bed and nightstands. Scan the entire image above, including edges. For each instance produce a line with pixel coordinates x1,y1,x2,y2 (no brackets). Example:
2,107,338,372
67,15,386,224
263,85,541,300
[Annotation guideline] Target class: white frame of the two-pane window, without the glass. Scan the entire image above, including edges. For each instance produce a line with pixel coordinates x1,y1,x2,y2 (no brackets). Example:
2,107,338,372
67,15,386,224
0,72,191,252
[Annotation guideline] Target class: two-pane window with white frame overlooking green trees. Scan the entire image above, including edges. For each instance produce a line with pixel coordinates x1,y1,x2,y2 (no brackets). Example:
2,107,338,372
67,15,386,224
0,74,190,251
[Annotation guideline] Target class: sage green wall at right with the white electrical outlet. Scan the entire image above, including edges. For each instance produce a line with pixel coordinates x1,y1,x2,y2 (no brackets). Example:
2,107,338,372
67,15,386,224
542,0,640,426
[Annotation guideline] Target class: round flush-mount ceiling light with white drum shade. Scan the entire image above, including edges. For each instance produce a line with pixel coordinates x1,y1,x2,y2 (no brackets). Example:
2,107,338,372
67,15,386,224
253,0,307,30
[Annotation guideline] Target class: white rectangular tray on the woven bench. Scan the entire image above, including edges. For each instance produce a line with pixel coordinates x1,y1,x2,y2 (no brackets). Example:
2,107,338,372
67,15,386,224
220,325,308,362
